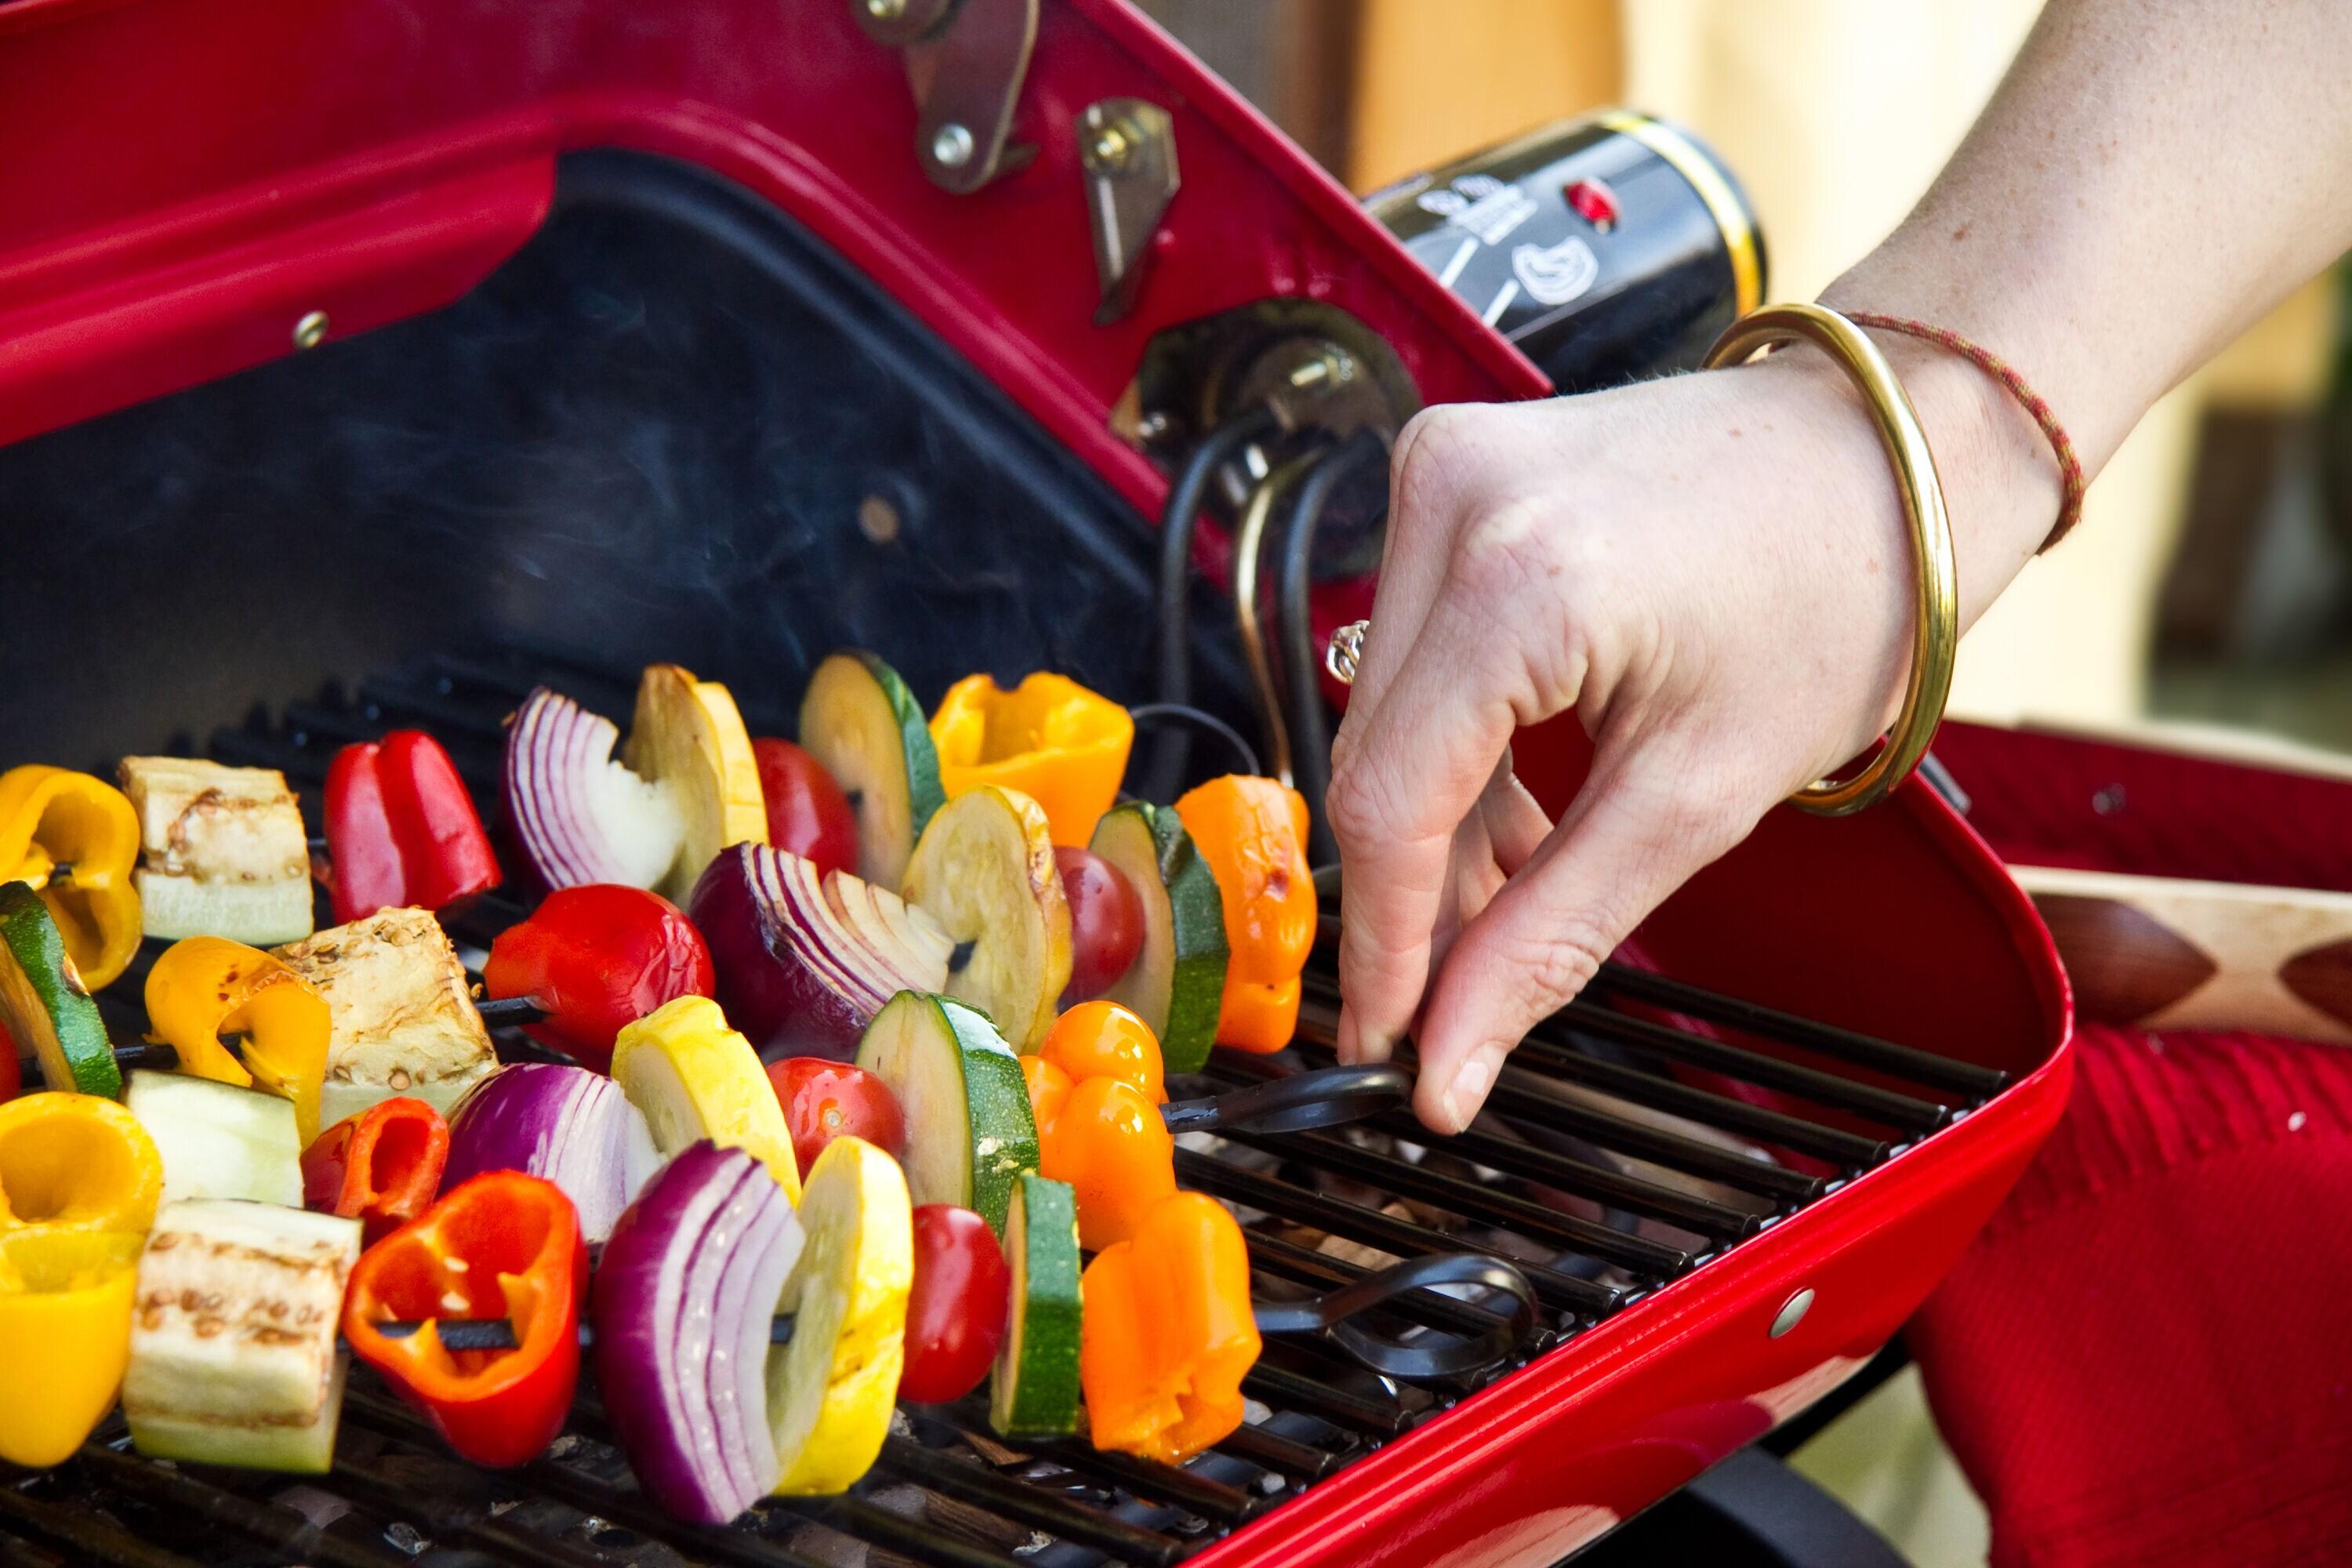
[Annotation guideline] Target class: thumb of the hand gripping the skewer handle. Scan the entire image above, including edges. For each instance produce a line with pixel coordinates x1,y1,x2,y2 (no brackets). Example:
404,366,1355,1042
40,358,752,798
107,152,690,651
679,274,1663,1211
1414,748,1748,1133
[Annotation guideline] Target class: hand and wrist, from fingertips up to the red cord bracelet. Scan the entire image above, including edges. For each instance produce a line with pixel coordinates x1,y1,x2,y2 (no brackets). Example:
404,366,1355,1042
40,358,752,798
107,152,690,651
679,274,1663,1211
1327,339,2056,1131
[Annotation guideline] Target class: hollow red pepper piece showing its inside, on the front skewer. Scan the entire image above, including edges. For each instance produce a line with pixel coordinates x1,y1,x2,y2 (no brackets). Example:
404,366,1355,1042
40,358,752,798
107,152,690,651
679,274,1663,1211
343,1171,588,1465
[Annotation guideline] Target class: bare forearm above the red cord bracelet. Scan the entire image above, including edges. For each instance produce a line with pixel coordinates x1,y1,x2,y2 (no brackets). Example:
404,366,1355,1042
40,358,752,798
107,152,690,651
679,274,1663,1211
1828,0,2352,473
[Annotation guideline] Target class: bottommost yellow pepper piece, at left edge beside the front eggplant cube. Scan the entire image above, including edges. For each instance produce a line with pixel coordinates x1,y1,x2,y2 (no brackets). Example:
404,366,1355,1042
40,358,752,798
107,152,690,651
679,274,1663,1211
0,1232,146,1467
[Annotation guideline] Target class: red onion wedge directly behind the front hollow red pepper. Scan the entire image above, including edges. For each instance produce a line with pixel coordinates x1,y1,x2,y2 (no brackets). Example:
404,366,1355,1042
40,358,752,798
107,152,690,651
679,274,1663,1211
442,1062,661,1241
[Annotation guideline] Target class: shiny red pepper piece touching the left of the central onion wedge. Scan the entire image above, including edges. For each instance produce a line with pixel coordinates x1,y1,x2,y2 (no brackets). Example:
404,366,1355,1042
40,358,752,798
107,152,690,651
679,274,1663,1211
482,881,713,1072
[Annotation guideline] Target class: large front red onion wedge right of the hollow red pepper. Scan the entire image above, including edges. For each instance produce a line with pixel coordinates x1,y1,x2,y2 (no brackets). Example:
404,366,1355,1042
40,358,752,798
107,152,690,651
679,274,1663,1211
590,1142,802,1523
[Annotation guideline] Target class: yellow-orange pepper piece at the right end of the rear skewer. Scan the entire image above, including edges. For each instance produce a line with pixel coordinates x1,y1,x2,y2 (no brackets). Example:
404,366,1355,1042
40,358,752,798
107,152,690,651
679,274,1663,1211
931,670,1136,848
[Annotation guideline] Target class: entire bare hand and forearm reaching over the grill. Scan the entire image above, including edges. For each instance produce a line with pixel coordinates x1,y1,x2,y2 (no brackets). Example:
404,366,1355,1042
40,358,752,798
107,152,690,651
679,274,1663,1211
1327,0,2352,1128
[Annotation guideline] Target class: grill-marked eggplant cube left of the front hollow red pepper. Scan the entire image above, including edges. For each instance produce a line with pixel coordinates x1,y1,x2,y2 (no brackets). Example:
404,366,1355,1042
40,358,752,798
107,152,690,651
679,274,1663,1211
122,1199,360,1474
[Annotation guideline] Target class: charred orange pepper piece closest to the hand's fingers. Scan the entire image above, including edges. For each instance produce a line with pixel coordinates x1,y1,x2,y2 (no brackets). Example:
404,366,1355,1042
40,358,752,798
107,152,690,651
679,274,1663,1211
1176,774,1315,1051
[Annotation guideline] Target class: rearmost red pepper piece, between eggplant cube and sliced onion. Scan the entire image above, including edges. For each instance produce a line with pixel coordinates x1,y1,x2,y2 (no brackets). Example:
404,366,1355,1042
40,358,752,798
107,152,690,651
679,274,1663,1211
327,729,499,924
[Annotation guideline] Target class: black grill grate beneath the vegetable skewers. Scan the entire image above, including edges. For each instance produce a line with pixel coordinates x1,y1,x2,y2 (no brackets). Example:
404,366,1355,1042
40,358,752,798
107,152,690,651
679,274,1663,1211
0,652,2004,1568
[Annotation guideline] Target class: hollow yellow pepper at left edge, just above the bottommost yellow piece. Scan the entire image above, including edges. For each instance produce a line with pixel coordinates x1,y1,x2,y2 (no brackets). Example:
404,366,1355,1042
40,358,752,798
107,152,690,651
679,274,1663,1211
0,1093,162,1241
